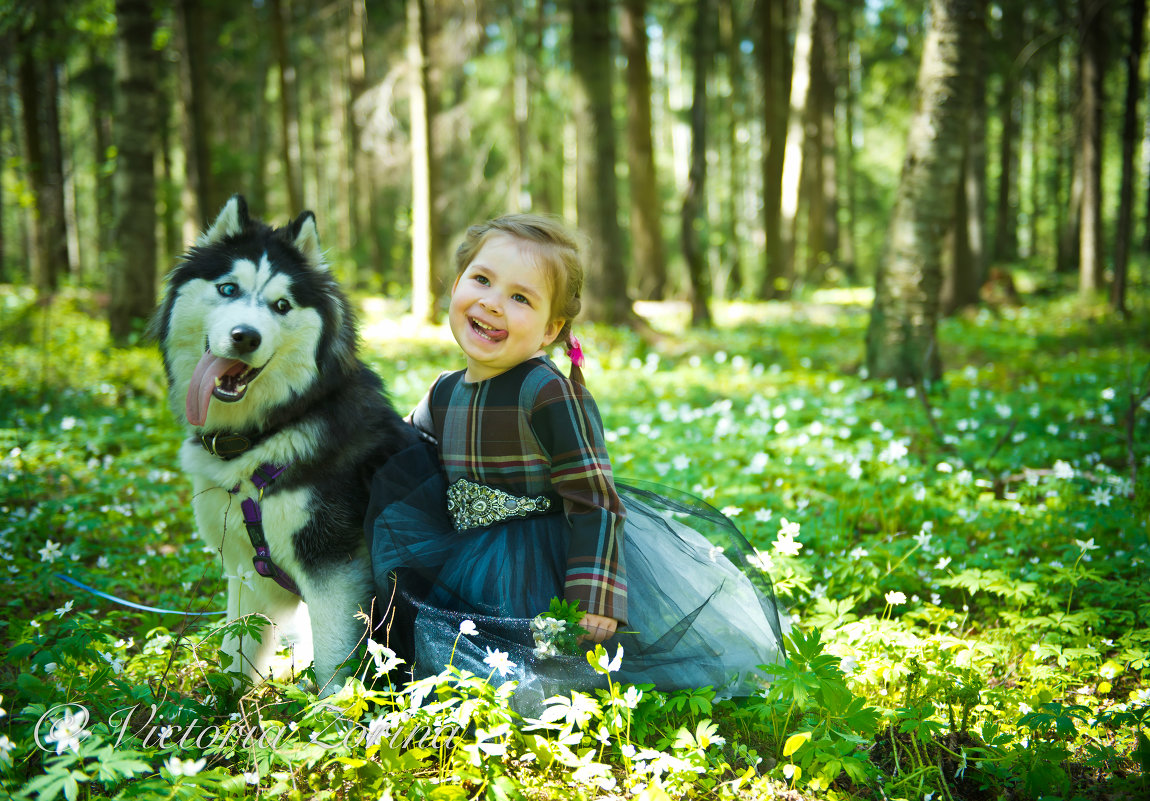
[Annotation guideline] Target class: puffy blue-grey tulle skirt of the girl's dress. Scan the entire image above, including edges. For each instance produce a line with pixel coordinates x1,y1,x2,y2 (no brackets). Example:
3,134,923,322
367,444,785,715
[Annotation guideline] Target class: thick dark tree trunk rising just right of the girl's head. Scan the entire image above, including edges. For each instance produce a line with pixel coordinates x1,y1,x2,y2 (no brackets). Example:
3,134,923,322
569,0,634,324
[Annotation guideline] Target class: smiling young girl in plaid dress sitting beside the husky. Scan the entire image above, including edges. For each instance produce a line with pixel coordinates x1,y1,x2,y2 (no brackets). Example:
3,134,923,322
367,215,783,711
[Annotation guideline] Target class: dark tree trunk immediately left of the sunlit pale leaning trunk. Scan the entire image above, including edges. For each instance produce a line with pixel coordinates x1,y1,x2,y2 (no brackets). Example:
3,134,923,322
754,0,791,300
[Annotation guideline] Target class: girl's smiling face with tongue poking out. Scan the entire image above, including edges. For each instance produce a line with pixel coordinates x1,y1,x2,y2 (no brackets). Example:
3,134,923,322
447,232,564,382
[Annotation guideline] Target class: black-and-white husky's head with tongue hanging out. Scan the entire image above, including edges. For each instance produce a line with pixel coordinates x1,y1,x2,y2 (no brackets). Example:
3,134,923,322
153,195,358,431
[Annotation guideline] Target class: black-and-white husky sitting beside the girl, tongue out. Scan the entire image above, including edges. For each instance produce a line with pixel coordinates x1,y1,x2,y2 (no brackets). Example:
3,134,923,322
153,195,413,694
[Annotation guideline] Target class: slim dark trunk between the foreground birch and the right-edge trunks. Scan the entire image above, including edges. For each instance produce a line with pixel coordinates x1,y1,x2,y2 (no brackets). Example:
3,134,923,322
994,2,1022,261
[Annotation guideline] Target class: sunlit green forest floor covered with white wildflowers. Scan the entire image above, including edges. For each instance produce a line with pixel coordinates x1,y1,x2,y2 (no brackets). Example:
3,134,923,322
0,287,1150,801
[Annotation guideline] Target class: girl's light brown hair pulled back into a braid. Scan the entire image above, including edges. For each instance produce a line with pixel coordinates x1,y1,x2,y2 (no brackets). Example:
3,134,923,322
455,214,583,383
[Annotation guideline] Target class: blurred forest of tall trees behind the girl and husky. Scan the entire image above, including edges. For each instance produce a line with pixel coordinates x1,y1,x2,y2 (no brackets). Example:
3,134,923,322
0,0,1150,370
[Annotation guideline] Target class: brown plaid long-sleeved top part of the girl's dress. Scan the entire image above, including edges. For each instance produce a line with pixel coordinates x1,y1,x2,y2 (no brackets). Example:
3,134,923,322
411,357,627,622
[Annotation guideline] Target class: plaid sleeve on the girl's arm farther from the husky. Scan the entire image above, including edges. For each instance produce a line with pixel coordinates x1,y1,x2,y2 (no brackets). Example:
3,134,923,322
531,376,627,623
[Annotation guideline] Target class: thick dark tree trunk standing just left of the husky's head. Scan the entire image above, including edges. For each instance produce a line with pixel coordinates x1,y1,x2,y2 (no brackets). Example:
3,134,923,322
108,0,158,346
